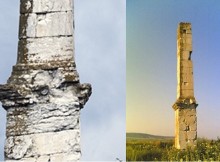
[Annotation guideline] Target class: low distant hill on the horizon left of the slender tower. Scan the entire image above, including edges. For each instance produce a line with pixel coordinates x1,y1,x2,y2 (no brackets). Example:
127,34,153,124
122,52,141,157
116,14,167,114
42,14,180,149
126,133,174,139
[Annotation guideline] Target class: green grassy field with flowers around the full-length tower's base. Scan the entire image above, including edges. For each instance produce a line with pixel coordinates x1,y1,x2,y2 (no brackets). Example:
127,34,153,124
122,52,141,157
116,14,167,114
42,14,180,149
126,138,220,161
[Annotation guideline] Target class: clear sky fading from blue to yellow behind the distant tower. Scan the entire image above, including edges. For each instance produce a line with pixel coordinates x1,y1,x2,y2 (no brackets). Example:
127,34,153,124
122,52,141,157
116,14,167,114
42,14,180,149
126,0,220,139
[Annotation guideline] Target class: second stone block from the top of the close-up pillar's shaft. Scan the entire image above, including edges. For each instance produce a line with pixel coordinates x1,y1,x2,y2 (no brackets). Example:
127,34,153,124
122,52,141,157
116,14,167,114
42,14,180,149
19,11,73,38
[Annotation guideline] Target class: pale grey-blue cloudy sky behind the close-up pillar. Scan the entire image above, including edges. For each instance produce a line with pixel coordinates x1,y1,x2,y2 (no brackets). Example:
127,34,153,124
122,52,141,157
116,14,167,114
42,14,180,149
0,0,126,161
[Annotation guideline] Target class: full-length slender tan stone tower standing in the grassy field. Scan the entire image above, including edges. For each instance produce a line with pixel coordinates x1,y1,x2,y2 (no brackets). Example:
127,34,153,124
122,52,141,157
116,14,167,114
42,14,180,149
173,23,198,149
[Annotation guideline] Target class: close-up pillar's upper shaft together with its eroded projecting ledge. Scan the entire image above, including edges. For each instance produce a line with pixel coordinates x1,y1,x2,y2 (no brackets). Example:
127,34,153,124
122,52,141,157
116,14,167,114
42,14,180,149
0,0,91,109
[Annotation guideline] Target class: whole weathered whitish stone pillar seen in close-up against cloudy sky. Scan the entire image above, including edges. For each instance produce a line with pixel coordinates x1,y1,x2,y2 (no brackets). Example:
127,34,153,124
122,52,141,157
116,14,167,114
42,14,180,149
0,0,91,162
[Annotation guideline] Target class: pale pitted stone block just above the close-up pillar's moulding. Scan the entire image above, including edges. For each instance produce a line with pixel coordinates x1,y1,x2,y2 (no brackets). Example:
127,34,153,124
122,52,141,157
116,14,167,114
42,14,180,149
18,37,74,63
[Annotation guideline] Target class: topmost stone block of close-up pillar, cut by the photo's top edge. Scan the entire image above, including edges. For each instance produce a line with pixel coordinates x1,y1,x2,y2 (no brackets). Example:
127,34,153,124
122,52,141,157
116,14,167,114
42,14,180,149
20,0,73,14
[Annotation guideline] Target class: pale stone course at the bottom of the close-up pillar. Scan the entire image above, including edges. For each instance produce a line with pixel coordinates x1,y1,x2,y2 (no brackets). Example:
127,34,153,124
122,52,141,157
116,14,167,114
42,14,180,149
5,130,80,162
